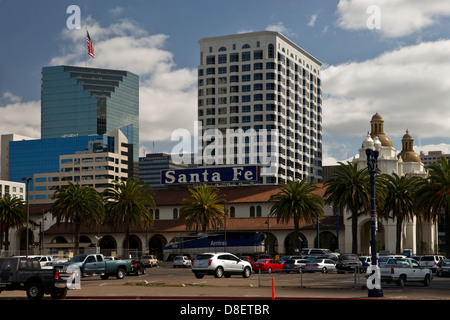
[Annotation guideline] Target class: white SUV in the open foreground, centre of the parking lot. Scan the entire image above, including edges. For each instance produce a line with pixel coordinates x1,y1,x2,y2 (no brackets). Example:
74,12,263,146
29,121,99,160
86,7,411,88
192,252,252,279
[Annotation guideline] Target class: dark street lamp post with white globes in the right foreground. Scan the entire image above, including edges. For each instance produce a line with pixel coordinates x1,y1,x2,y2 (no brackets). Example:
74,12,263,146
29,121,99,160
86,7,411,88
363,134,383,297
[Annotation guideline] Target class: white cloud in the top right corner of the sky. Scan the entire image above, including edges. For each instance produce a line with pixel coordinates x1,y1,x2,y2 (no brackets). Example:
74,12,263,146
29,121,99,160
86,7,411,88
336,0,450,37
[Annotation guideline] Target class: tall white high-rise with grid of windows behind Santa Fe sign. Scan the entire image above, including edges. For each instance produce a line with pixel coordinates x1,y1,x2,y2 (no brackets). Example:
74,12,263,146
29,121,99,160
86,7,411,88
198,31,322,183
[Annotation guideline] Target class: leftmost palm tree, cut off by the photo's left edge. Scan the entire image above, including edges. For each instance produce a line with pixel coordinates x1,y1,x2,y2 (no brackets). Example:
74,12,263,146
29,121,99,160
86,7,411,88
0,194,28,254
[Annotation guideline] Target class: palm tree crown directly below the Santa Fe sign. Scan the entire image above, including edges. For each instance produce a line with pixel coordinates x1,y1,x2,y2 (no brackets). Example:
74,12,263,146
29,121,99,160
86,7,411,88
179,184,227,232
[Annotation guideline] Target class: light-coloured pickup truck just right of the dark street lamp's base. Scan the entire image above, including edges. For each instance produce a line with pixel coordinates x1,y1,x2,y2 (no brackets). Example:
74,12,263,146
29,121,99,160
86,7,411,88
380,258,432,287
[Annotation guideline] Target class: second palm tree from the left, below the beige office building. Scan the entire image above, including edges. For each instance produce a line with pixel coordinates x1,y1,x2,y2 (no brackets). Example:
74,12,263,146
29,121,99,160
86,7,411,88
51,182,104,254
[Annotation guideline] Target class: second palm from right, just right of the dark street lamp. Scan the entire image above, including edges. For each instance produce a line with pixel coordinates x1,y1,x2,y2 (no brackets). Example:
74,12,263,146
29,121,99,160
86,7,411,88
378,173,420,253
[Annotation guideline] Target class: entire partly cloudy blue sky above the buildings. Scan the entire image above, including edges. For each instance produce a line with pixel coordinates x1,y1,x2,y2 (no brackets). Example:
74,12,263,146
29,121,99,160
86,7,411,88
0,0,450,165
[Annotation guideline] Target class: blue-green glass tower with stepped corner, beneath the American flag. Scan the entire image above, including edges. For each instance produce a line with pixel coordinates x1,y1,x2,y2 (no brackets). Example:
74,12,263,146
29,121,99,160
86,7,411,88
41,66,139,166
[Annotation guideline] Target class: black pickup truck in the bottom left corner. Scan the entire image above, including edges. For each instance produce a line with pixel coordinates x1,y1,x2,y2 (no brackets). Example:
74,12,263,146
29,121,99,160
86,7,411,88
0,257,67,300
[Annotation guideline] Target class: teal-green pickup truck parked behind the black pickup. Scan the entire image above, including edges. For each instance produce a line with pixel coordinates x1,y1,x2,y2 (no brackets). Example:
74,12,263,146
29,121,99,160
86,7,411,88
55,254,131,280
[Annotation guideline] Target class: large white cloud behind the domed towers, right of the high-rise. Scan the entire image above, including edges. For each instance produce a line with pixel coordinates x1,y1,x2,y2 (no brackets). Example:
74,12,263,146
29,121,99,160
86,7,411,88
322,40,450,138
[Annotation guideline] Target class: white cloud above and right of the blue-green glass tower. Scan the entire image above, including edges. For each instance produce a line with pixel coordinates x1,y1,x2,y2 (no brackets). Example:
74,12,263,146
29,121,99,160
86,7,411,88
50,18,197,145
